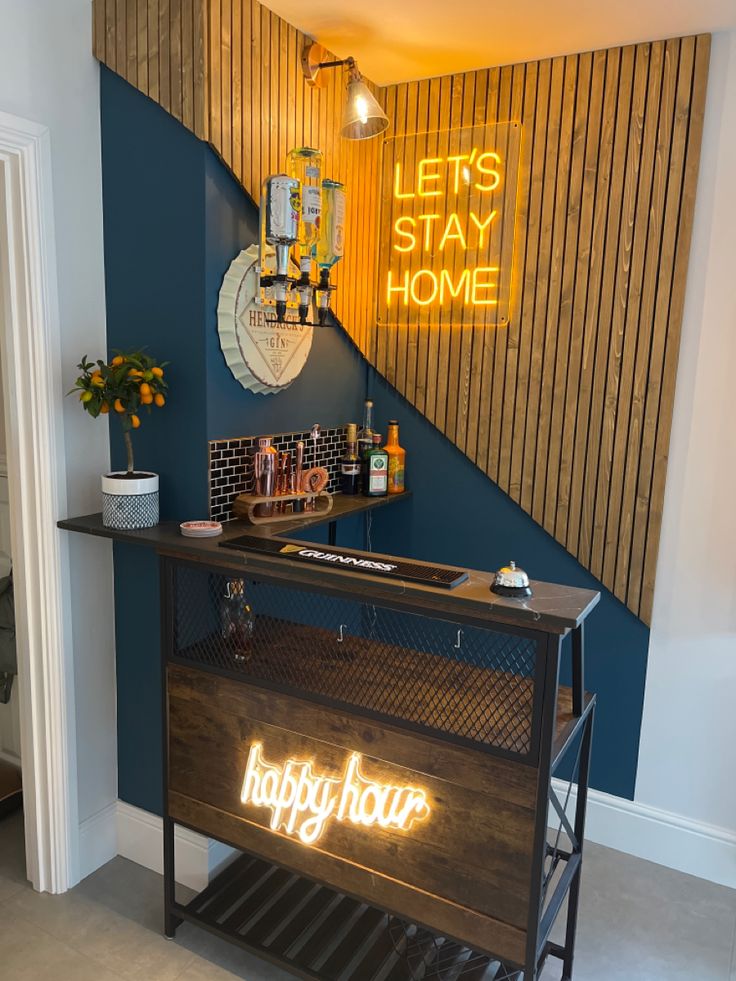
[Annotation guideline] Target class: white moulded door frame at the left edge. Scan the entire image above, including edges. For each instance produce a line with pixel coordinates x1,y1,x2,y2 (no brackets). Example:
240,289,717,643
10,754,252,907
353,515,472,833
0,112,79,893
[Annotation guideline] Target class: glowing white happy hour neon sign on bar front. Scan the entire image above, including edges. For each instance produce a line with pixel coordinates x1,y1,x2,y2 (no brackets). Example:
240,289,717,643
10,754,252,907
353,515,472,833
240,742,430,845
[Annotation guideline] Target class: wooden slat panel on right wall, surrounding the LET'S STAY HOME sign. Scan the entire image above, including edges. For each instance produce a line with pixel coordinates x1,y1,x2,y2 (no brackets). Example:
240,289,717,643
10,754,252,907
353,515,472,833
376,36,710,622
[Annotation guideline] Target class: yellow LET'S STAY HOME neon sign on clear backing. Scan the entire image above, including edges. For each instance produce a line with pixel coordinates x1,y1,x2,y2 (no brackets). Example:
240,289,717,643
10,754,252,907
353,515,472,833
378,123,521,324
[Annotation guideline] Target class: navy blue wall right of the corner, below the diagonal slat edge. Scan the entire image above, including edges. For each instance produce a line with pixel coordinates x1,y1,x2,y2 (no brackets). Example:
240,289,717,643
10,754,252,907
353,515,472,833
368,369,649,799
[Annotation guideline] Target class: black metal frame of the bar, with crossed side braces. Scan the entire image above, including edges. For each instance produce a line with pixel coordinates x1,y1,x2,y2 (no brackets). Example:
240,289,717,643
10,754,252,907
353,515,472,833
159,556,595,981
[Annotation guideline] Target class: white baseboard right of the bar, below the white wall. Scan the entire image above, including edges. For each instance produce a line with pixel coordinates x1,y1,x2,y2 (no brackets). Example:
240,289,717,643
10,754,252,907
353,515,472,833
551,780,736,889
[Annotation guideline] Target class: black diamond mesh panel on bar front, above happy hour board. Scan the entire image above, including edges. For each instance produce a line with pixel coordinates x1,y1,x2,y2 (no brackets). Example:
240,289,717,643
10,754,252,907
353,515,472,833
174,565,536,755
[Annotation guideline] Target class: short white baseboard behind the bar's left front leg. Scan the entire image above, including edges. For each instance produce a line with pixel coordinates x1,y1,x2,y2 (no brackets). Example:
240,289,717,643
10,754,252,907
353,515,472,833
117,801,233,892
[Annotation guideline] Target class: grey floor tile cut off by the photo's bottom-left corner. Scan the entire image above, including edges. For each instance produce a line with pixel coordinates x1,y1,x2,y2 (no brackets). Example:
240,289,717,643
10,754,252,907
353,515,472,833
0,906,120,981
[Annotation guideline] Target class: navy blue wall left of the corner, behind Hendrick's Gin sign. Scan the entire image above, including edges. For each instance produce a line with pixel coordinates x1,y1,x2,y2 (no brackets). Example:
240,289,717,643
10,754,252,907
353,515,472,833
99,67,365,813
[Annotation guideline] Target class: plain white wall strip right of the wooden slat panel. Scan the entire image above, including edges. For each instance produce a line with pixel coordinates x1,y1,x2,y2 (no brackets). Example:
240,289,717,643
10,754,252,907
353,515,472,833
636,31,736,831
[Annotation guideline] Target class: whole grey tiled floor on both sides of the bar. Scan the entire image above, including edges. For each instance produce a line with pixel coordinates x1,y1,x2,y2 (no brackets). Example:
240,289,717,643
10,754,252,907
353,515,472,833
0,814,736,981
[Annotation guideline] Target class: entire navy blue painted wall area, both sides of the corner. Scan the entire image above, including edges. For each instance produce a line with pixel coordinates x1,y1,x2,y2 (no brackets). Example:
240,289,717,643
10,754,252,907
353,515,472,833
100,68,648,812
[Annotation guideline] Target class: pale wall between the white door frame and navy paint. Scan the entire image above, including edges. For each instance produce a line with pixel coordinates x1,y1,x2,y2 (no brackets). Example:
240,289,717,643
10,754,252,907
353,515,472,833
0,0,117,865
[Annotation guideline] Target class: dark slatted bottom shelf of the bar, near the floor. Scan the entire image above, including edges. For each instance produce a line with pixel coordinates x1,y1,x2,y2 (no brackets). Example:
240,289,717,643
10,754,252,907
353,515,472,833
171,854,521,981
